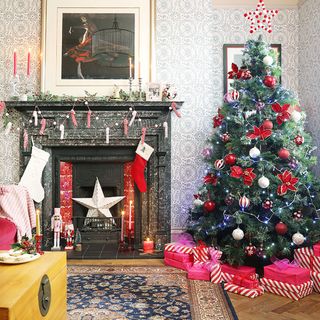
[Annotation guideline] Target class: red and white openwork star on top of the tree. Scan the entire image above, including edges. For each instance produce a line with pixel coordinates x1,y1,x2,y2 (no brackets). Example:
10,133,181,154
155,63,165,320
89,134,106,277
244,0,279,33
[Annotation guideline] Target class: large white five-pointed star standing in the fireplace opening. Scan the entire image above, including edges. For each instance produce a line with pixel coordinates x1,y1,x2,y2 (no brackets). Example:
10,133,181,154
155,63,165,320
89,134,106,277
72,178,125,218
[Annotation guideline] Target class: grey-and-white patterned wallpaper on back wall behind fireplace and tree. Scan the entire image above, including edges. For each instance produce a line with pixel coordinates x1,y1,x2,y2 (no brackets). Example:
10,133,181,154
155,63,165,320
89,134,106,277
0,0,308,234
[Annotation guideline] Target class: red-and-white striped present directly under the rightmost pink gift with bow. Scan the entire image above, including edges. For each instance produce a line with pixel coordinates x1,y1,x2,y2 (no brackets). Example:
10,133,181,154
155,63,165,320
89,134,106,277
260,278,313,300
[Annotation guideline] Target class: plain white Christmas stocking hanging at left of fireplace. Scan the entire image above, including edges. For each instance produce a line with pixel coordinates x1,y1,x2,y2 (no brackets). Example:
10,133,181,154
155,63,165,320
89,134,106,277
19,146,50,202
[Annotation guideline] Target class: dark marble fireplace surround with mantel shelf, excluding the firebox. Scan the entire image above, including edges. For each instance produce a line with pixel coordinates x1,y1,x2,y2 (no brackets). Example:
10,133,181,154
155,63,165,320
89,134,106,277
6,101,182,249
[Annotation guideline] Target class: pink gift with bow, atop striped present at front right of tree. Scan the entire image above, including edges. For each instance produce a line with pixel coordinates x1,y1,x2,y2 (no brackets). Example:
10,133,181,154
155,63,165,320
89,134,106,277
264,259,310,285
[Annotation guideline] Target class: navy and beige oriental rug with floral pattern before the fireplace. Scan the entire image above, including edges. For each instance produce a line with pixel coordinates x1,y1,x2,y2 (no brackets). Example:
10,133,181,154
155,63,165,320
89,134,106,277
68,265,236,320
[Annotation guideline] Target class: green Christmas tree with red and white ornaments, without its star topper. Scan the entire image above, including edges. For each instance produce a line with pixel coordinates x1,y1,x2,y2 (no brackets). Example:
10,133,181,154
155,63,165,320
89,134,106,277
188,36,320,265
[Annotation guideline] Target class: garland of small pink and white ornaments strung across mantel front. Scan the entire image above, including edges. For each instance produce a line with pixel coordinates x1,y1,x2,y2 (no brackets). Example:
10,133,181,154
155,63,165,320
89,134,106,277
0,99,181,150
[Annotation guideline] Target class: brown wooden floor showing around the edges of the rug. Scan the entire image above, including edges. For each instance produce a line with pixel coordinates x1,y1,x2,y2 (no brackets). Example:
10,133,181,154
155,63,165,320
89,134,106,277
68,259,320,320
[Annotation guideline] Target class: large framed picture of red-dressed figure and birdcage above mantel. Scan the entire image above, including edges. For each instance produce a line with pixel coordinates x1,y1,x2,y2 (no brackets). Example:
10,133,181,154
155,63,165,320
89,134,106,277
41,0,156,96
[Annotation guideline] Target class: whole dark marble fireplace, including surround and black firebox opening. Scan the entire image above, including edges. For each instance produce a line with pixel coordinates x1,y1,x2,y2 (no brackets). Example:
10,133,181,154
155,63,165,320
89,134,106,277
7,102,181,258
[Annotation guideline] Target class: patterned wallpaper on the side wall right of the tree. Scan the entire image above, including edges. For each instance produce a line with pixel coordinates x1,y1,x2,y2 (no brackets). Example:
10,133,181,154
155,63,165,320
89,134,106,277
299,0,320,175
